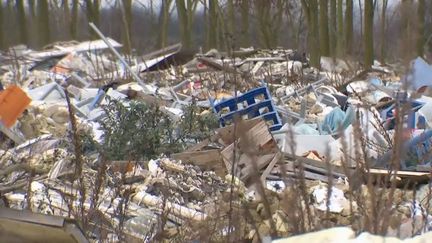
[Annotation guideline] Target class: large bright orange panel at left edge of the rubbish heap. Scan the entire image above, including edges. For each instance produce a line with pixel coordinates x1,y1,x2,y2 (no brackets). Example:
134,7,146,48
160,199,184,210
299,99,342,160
0,85,31,127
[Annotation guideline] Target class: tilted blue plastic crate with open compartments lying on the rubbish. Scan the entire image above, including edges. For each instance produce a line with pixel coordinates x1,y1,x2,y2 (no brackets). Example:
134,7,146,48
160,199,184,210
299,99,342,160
211,86,282,131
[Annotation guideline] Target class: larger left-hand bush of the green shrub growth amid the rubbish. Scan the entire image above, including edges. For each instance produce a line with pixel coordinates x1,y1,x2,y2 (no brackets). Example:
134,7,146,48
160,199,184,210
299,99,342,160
101,99,180,160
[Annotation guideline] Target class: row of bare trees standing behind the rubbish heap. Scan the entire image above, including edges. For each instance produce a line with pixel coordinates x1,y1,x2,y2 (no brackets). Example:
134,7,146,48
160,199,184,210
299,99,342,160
0,0,432,67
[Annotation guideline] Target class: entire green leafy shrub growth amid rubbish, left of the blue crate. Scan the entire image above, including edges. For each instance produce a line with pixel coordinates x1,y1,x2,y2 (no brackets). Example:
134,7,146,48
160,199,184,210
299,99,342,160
101,99,218,160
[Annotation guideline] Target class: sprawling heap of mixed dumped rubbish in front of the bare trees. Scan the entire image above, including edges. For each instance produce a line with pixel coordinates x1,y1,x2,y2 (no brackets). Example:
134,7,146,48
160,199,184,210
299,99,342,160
0,26,432,242
